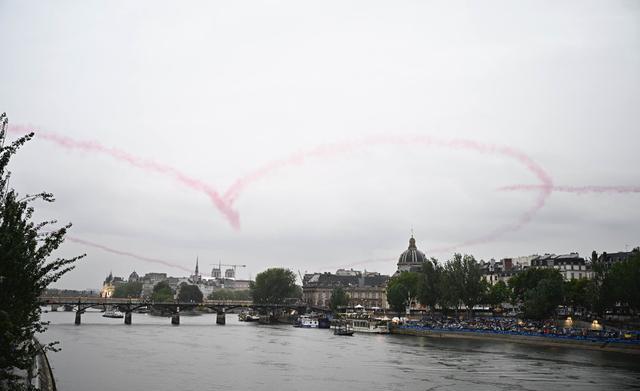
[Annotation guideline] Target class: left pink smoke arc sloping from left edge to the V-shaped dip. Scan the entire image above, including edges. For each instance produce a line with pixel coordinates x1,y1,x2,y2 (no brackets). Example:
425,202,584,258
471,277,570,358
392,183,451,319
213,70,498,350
9,126,240,229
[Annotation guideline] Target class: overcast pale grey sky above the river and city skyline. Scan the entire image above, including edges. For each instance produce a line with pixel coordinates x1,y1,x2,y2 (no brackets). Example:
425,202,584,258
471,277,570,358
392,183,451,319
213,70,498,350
0,0,640,288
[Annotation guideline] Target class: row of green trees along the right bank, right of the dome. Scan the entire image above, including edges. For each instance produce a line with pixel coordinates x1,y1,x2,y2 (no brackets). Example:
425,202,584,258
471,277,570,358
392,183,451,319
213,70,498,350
387,248,640,319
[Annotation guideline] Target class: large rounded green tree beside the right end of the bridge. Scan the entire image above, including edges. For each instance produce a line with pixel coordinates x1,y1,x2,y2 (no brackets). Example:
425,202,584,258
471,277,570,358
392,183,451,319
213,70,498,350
249,268,301,304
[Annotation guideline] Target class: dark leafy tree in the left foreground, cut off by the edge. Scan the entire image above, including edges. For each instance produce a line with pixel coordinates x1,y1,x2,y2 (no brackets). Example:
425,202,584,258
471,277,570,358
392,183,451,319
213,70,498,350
0,114,84,390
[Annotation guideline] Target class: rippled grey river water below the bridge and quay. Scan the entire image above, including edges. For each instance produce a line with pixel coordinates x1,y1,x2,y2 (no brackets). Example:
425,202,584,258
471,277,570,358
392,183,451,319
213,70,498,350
41,312,640,391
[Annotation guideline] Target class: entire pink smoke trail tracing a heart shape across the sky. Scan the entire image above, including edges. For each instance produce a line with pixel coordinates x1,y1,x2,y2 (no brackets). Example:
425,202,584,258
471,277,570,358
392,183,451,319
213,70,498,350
9,126,640,267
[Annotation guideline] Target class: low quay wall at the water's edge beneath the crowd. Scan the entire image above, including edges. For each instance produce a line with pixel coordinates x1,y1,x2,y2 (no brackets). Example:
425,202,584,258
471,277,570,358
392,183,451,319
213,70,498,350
390,326,640,355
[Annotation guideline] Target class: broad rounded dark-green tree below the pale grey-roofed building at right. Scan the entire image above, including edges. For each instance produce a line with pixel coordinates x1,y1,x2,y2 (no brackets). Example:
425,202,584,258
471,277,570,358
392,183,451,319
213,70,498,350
509,268,564,319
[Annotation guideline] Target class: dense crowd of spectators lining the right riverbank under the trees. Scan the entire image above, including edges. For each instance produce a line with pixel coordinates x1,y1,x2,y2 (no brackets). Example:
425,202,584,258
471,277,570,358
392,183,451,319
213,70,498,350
401,316,640,342
